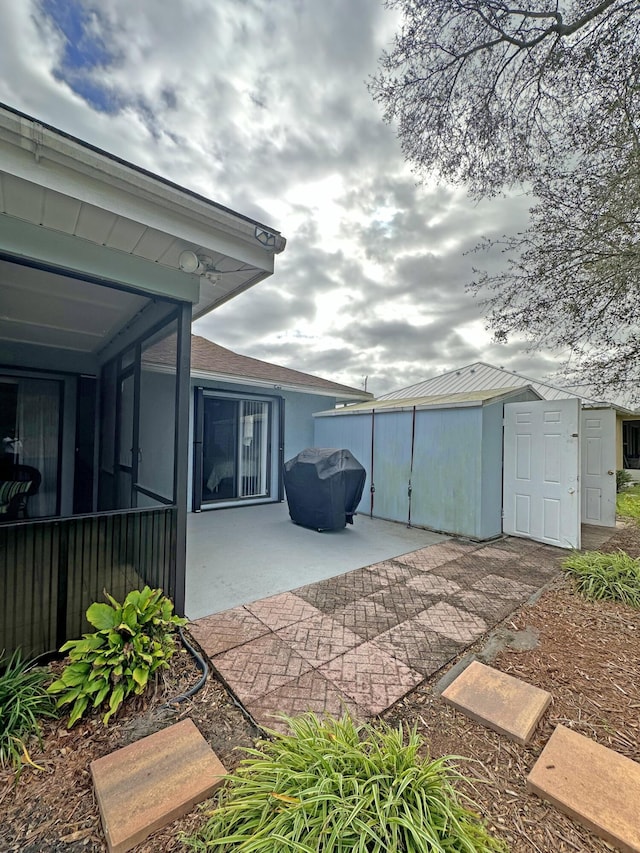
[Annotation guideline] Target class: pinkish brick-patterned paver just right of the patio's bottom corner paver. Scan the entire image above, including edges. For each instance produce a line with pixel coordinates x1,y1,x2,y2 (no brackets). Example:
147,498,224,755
318,643,424,714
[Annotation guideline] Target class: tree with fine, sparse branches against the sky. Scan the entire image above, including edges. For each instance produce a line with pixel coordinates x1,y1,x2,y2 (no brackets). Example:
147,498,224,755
370,0,640,402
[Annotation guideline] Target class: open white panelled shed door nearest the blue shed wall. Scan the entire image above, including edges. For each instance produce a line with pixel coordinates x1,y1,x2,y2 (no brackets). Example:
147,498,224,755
503,399,580,548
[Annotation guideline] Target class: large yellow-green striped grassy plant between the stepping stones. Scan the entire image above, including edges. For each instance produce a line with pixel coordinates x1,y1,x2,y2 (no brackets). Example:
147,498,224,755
182,714,506,853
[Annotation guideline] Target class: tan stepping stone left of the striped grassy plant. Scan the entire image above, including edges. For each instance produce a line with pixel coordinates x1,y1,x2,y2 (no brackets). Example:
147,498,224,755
90,719,227,853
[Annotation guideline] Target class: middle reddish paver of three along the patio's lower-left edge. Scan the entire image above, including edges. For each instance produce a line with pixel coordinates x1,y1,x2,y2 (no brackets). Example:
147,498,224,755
213,634,311,703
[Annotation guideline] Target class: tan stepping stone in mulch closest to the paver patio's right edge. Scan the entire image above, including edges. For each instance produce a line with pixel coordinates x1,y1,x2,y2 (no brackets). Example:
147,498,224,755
442,661,551,746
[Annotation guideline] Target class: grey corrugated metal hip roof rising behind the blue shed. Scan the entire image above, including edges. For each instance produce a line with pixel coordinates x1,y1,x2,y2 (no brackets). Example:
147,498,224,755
380,361,616,405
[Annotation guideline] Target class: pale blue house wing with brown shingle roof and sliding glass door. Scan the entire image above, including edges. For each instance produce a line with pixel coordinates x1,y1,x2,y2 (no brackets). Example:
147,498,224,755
189,335,373,511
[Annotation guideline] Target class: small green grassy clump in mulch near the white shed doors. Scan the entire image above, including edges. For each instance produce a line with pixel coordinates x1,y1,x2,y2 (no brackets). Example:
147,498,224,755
562,551,640,608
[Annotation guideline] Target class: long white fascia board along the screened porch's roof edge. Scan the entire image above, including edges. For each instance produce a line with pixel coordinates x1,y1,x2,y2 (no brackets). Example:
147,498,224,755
0,109,284,273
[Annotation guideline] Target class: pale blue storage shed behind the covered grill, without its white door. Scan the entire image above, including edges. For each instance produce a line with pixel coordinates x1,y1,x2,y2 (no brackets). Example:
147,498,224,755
314,387,541,540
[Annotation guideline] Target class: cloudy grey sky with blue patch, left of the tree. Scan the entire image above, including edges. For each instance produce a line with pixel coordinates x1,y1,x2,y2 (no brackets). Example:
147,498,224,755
0,0,568,393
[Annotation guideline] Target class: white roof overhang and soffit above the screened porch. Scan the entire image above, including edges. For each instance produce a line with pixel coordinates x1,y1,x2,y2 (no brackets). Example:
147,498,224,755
0,105,285,364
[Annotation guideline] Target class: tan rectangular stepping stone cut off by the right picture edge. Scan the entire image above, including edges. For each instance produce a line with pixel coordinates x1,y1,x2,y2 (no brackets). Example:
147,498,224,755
527,726,640,853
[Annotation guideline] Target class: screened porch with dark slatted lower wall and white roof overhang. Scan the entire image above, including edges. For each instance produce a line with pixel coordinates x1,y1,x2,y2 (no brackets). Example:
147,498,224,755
0,105,285,655
